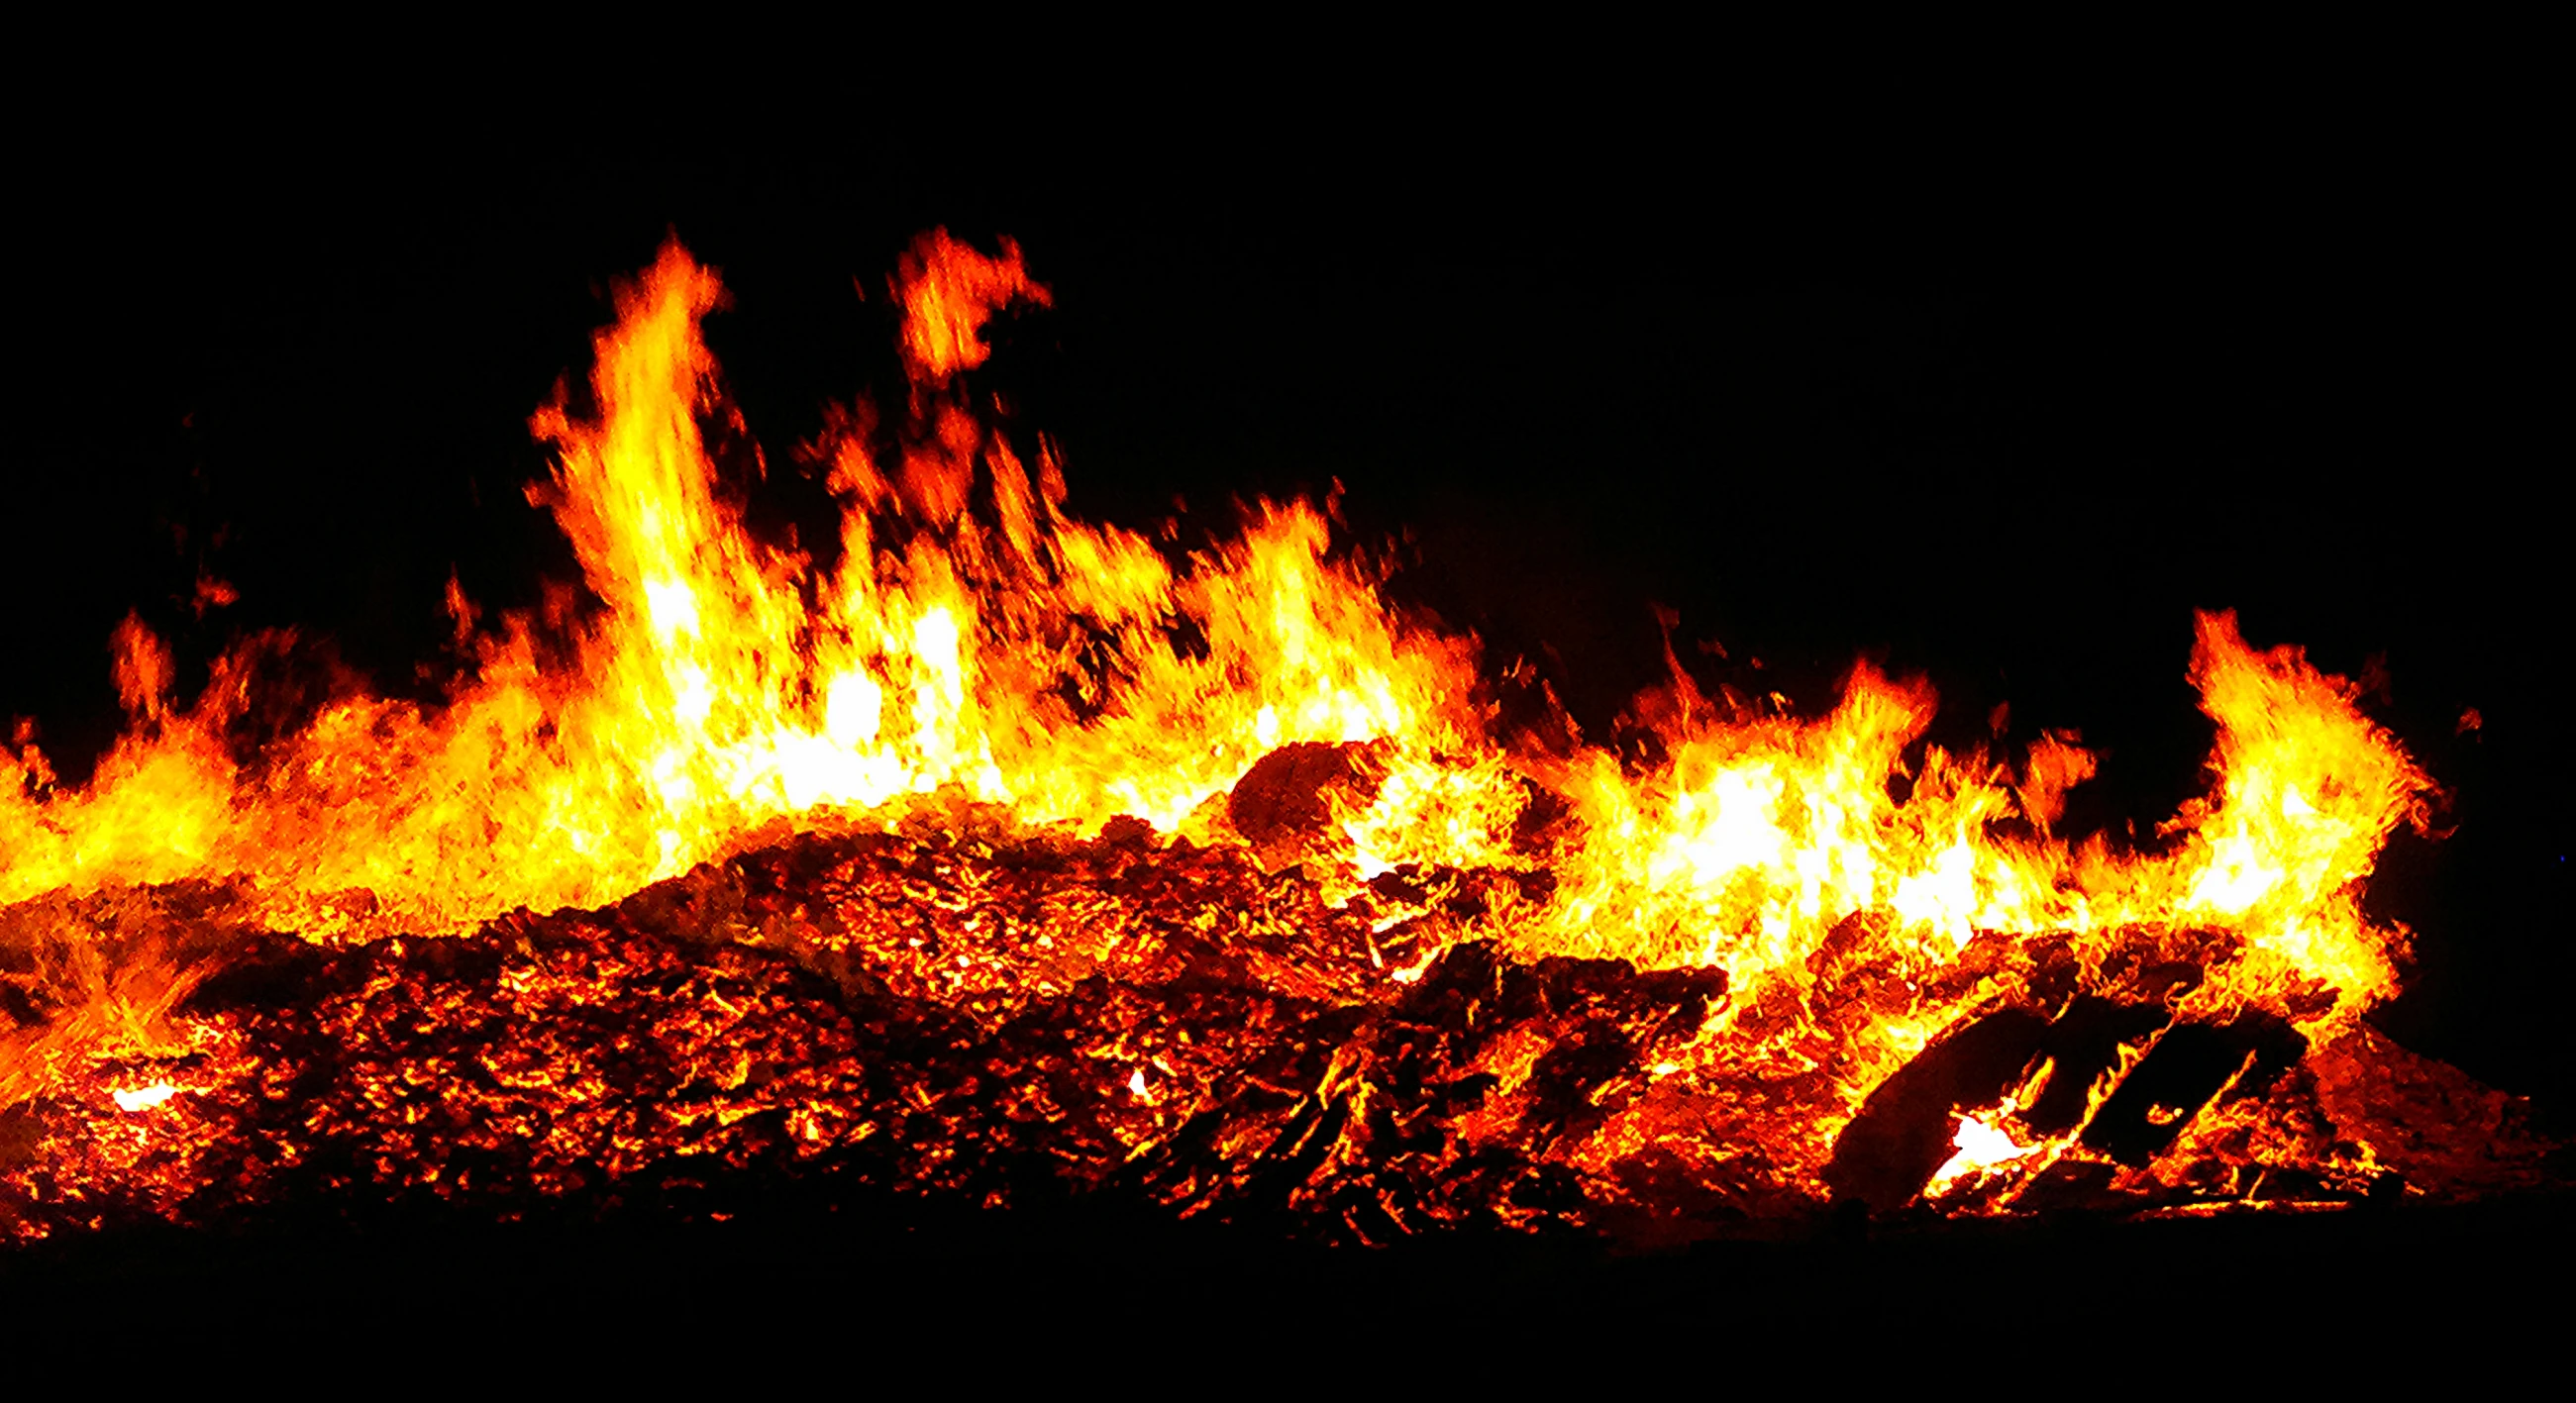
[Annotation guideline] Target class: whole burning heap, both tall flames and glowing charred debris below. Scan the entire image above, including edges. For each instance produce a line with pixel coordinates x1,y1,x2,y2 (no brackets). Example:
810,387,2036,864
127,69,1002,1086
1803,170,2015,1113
0,232,2542,1241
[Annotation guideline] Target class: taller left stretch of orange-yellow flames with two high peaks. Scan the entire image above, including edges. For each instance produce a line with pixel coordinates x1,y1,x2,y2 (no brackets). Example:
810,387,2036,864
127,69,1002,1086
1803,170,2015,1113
0,235,1479,937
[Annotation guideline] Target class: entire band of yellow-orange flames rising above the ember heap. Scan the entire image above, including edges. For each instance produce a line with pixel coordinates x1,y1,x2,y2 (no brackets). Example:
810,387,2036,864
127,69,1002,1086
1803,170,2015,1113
0,235,2429,1117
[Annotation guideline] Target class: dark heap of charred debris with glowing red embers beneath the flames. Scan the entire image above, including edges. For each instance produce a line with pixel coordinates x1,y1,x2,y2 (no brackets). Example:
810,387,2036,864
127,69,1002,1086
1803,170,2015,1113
0,756,2547,1246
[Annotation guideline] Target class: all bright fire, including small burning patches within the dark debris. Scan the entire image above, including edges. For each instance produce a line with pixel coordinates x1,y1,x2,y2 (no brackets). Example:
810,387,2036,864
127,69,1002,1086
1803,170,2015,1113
0,232,2534,1246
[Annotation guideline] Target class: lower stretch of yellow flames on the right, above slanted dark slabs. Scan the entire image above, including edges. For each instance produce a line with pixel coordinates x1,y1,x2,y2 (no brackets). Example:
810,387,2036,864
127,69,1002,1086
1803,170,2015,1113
1503,613,2431,1040
